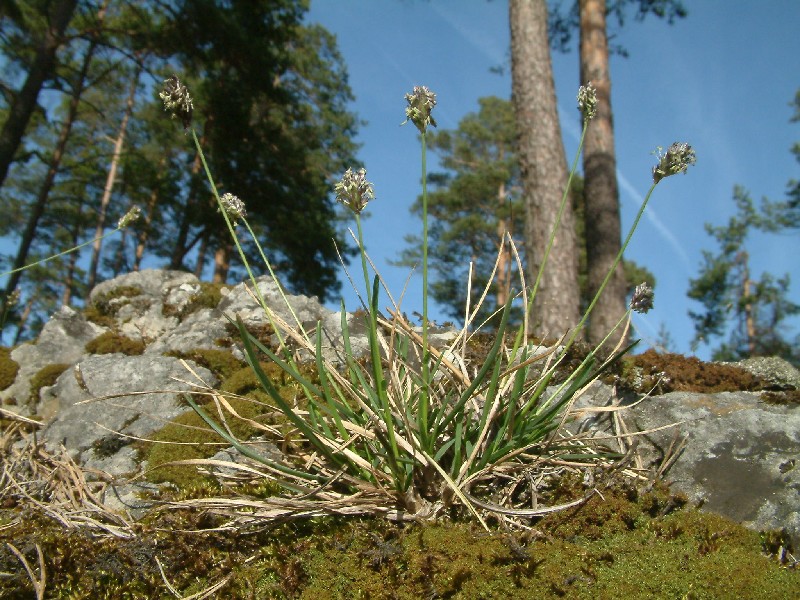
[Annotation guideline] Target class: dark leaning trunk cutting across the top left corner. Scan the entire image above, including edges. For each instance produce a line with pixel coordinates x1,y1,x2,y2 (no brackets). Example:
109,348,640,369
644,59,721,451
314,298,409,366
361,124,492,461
0,0,78,188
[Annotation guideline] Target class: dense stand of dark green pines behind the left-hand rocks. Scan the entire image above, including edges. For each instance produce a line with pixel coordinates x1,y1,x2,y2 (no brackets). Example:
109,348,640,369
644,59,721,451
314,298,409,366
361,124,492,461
0,0,358,342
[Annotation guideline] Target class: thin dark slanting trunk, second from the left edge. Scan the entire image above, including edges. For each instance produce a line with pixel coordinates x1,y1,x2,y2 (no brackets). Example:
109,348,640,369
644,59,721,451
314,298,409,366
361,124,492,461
3,32,96,307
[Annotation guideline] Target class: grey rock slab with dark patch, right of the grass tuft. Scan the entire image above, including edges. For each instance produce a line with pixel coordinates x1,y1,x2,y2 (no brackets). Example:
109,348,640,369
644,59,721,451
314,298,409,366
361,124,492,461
573,384,800,547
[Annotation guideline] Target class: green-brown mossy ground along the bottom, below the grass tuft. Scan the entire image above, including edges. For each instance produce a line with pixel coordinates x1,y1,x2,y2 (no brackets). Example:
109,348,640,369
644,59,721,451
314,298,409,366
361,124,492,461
0,476,800,600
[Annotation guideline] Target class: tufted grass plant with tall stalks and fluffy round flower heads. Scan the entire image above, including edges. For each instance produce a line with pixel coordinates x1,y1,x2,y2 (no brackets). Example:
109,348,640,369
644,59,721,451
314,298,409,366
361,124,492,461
153,76,694,527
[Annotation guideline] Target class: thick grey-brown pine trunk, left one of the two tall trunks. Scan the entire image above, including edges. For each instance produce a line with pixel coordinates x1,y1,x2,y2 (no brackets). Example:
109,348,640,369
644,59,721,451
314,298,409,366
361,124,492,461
509,0,580,336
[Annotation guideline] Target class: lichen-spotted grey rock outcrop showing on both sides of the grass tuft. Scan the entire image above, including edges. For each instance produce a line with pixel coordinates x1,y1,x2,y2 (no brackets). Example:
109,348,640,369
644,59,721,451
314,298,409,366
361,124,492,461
0,270,800,547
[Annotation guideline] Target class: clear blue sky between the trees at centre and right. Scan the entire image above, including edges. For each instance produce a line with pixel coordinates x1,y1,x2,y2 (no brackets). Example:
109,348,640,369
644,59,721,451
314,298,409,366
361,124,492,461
307,0,800,358
